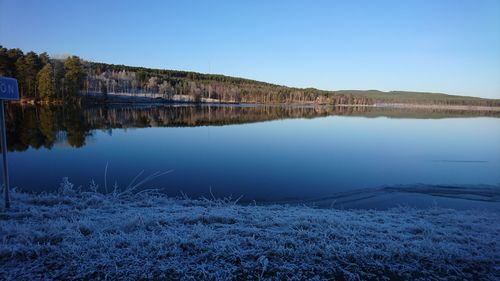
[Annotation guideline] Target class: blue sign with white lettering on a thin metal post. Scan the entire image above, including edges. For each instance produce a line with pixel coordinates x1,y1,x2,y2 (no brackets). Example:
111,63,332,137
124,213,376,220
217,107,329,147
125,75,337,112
0,76,19,209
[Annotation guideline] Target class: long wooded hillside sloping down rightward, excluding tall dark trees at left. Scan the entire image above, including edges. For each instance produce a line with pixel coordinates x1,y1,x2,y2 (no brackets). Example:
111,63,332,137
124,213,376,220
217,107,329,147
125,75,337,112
84,60,500,106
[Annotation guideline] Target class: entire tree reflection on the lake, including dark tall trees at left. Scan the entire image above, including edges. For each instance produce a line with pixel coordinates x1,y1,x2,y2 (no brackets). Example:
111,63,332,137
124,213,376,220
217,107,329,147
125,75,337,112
6,104,499,151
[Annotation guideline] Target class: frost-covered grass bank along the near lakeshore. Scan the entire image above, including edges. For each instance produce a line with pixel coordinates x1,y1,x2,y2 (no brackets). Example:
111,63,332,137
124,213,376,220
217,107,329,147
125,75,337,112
0,181,500,280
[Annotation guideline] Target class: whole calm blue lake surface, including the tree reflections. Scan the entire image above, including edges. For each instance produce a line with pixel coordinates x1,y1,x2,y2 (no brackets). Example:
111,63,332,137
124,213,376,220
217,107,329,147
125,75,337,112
3,104,500,208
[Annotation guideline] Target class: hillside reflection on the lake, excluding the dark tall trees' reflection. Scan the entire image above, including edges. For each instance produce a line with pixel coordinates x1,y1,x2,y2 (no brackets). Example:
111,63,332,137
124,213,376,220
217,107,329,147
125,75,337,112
84,105,500,128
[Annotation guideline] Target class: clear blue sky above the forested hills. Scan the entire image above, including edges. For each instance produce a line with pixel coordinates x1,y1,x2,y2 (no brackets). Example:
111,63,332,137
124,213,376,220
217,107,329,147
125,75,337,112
0,0,500,98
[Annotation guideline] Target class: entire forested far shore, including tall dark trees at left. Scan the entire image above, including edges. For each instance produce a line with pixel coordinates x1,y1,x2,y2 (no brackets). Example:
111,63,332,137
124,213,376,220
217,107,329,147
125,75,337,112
0,46,500,106
